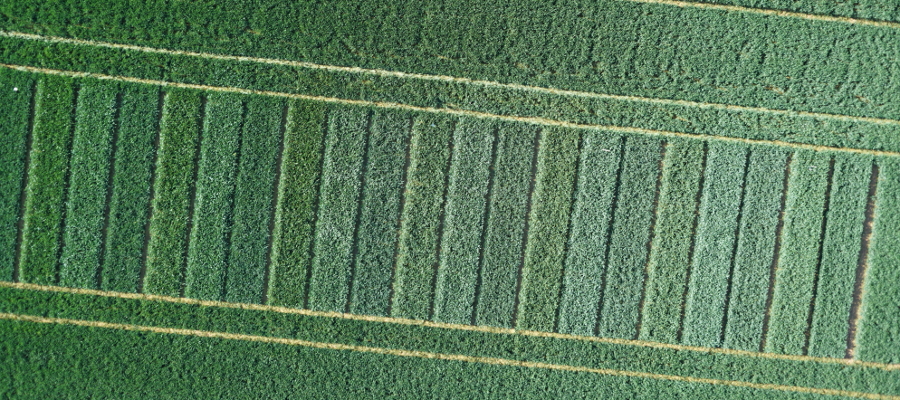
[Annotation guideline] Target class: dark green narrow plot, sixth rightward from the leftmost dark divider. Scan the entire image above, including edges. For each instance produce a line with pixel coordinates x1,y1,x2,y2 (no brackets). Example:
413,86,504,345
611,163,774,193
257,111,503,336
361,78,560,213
225,96,284,303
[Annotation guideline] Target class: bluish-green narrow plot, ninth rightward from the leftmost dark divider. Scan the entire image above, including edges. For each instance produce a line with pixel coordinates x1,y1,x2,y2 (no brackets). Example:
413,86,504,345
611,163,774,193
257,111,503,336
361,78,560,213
350,112,412,315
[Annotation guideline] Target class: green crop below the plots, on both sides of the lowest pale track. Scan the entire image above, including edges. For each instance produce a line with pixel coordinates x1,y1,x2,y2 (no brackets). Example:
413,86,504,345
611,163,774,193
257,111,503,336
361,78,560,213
0,288,900,399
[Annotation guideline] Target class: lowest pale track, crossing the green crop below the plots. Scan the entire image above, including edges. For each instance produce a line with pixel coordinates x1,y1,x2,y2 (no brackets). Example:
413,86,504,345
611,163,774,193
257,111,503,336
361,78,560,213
0,313,900,400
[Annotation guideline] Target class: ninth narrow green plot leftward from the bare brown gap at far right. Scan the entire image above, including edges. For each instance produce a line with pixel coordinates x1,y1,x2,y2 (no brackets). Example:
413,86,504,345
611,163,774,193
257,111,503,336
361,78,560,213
475,123,538,328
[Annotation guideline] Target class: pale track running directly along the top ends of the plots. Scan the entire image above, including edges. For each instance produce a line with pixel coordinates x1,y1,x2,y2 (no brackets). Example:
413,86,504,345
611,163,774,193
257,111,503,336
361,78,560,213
0,64,900,161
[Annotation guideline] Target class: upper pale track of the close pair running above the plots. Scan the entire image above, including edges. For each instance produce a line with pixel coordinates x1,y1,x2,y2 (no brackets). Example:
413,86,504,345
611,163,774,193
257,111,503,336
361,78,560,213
0,29,900,125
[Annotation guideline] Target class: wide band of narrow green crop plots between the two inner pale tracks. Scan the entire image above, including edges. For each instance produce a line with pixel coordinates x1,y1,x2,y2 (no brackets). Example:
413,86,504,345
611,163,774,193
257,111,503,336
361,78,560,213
2,73,896,357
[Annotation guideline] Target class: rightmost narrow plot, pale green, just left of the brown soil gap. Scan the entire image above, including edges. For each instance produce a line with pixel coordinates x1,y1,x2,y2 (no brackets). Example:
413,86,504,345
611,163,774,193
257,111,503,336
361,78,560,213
808,154,872,358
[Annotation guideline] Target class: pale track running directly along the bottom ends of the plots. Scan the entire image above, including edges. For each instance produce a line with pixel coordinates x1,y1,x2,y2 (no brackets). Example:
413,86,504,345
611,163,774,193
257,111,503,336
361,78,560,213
0,281,900,371
